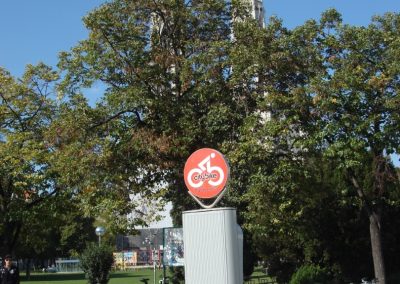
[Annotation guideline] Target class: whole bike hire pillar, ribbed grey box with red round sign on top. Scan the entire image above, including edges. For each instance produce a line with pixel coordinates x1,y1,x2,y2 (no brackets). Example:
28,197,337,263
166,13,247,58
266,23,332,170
183,148,243,284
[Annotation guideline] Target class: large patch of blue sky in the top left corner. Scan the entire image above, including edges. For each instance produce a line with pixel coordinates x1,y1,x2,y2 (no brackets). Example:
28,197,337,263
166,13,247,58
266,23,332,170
0,0,104,76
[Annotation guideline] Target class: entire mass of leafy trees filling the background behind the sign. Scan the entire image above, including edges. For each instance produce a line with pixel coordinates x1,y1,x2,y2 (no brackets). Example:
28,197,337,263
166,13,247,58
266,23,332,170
0,0,400,283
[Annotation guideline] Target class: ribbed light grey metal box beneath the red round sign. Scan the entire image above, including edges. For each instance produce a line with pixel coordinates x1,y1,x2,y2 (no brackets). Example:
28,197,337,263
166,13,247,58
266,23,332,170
183,208,243,284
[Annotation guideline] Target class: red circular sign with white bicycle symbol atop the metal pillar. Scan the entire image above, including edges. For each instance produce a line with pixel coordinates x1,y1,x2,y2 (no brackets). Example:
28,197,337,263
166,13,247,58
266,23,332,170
183,148,229,198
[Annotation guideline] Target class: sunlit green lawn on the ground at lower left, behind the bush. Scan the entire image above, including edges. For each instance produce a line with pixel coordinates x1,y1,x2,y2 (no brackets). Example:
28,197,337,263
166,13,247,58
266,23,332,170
21,268,168,284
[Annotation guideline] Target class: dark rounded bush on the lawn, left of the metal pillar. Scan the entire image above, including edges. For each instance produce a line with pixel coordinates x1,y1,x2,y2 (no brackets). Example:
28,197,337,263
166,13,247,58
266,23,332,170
79,244,114,284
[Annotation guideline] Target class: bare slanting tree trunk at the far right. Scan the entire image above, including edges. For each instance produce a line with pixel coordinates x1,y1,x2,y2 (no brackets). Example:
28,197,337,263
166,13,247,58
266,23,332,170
369,211,386,284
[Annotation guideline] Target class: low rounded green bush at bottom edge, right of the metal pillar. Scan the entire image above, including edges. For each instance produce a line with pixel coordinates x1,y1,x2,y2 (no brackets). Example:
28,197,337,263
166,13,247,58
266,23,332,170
289,265,330,284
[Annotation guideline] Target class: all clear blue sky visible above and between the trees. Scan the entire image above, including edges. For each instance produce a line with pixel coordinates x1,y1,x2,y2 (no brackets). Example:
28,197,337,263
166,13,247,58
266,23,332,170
0,0,400,165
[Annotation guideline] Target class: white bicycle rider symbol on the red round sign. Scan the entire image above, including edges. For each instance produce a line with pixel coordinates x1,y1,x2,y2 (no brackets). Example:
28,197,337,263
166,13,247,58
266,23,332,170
187,153,224,188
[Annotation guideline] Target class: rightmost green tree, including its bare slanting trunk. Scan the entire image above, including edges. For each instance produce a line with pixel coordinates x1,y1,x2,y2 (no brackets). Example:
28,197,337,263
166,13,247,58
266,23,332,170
312,11,400,283
